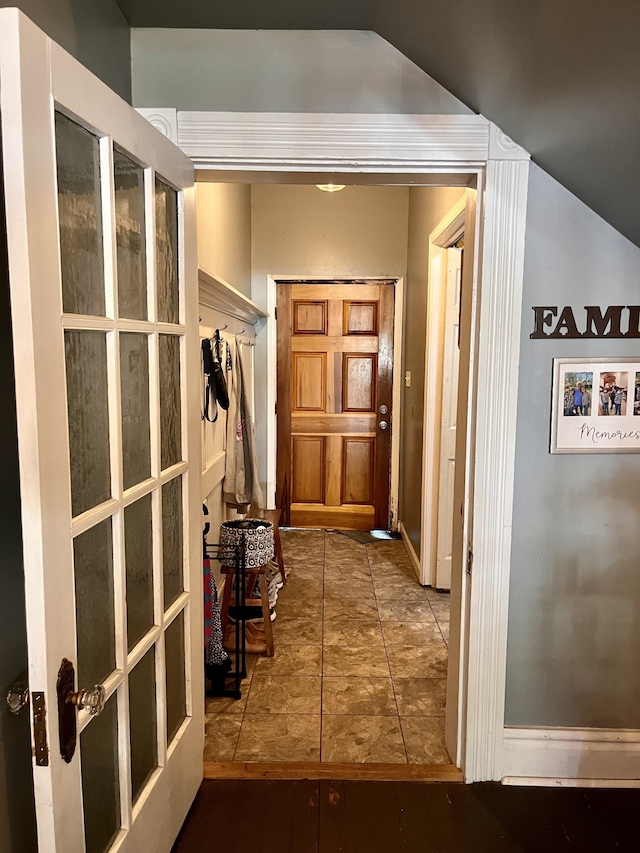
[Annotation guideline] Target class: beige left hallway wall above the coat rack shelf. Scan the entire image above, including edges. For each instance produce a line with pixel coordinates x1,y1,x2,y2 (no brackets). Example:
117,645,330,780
196,184,251,296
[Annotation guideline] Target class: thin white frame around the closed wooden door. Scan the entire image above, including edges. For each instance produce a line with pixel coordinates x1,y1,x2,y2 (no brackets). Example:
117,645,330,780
264,273,404,530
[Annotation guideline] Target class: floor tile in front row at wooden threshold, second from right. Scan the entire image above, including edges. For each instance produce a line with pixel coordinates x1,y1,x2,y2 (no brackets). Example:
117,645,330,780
322,715,407,764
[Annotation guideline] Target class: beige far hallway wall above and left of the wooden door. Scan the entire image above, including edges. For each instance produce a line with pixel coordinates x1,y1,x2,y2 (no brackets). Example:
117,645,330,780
251,184,409,506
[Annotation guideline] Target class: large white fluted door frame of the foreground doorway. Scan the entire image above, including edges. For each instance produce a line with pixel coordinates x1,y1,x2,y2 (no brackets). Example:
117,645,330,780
141,109,530,782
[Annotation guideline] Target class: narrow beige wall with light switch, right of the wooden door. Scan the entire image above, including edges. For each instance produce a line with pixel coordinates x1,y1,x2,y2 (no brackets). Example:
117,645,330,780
399,187,464,558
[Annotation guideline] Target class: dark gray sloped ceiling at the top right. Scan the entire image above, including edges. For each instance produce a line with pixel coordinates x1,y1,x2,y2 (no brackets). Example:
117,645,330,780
117,0,640,245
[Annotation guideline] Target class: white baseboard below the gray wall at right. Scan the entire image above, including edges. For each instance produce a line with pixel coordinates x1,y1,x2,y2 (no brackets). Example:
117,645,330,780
502,728,640,787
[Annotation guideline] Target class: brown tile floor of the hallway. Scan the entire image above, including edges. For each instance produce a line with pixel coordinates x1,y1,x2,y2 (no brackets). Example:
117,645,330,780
204,530,449,764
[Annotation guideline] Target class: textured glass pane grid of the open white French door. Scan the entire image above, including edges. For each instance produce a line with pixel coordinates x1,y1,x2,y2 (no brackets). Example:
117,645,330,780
55,113,189,853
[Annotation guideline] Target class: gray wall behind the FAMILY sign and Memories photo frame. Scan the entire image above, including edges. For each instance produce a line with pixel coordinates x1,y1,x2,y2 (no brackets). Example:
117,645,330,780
506,166,640,728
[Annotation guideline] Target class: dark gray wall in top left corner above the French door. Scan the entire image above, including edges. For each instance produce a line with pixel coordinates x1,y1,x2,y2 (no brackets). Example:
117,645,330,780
0,0,131,102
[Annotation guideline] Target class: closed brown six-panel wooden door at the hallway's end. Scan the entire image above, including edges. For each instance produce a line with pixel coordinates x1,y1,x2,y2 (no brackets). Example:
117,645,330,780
276,281,395,530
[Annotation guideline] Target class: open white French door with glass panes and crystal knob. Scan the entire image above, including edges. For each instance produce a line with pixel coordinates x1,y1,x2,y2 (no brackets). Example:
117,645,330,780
0,9,204,853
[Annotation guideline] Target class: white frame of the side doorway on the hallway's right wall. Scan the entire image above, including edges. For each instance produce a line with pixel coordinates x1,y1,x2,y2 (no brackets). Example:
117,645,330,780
420,195,466,586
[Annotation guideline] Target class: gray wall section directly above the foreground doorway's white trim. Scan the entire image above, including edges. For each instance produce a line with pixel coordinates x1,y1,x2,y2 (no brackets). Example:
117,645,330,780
131,29,470,114
